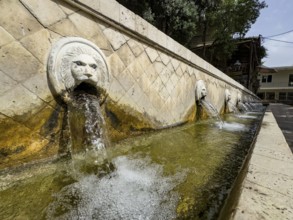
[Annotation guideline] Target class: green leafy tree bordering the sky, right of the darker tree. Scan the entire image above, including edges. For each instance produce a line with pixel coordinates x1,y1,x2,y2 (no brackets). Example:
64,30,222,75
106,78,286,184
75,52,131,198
196,0,266,63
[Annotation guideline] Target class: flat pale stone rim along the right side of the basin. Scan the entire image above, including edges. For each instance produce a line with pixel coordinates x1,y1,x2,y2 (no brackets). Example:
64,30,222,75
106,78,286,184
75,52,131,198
231,104,293,220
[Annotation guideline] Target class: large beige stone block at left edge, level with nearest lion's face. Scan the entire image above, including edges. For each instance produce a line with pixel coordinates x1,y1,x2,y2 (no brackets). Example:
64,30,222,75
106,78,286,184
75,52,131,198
0,42,41,82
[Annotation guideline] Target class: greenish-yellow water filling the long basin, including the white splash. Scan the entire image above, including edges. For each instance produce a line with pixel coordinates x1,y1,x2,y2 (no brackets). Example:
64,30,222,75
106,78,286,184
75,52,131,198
0,112,261,219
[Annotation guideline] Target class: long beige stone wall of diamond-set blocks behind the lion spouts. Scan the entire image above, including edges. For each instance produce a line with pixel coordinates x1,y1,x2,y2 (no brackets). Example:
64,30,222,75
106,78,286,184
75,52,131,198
0,0,256,169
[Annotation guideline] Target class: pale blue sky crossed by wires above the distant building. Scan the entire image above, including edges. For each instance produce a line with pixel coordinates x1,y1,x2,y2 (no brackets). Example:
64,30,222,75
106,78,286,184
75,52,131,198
246,0,293,67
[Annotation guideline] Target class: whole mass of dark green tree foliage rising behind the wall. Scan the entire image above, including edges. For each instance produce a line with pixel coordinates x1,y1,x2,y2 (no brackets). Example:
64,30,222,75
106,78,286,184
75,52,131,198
118,0,266,62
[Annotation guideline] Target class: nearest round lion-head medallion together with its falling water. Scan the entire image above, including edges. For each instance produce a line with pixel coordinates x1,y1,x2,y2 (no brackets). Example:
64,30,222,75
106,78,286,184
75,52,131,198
48,37,111,174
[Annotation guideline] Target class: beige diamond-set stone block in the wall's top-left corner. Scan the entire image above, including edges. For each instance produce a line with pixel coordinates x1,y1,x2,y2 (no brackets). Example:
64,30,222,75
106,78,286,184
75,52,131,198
0,0,42,39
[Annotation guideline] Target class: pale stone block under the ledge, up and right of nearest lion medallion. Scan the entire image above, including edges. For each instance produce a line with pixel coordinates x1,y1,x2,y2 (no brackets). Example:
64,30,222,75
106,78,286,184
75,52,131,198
69,11,101,39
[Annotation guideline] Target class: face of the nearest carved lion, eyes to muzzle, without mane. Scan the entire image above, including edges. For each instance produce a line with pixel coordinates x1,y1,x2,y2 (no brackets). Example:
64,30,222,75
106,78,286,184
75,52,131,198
71,54,98,85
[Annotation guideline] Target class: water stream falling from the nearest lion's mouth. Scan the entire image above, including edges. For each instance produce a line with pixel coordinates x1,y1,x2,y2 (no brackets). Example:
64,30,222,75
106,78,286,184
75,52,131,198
67,91,111,175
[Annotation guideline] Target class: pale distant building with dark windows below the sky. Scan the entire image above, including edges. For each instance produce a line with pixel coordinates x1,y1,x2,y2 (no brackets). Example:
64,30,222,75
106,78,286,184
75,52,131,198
257,66,293,104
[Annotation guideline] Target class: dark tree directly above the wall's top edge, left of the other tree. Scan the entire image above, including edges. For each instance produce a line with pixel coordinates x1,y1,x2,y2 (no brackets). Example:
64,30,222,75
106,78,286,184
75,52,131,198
118,0,197,46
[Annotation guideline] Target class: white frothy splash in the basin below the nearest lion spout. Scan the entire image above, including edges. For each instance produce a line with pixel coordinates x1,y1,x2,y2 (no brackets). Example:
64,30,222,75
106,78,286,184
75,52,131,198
46,156,185,219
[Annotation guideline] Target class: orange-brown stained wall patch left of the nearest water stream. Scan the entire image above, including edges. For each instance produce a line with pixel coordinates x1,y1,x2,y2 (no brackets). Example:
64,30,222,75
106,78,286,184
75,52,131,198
0,103,63,170
